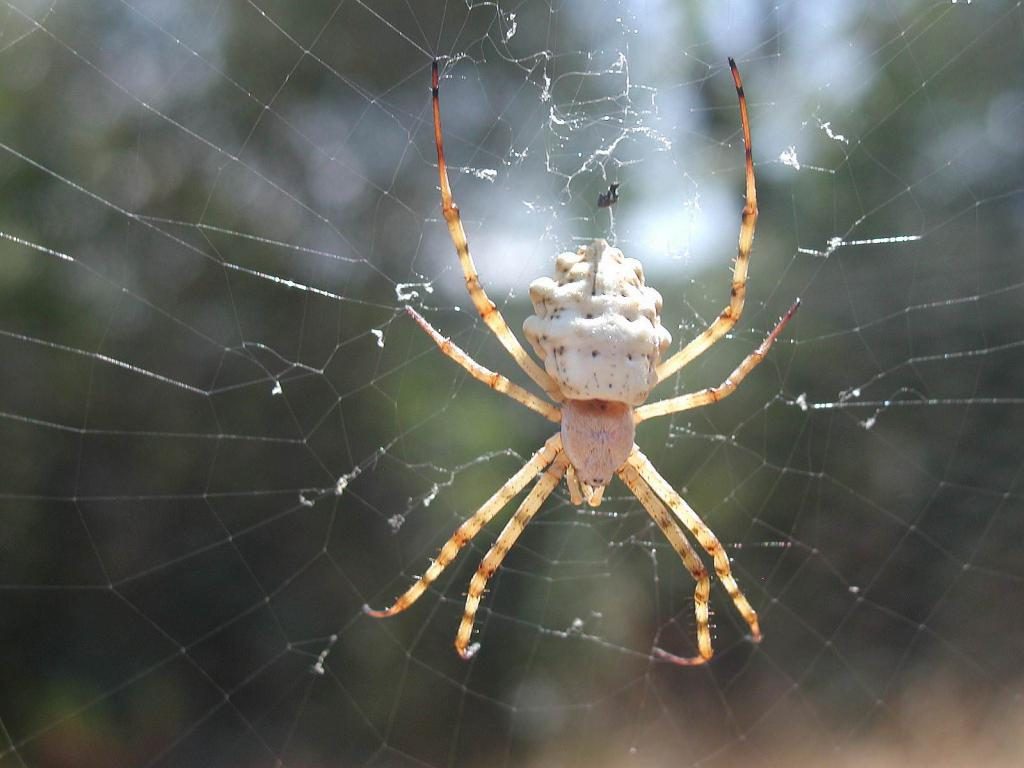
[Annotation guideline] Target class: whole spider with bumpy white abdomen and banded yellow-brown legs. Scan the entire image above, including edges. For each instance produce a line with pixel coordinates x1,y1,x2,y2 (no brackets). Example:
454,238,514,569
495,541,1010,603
364,58,800,666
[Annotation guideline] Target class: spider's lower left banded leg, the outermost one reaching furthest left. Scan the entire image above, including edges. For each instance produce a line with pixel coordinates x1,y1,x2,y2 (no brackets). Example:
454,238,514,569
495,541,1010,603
362,434,562,618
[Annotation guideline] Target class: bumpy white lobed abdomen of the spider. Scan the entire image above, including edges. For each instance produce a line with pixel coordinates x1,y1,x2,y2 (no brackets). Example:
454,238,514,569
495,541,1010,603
523,240,672,406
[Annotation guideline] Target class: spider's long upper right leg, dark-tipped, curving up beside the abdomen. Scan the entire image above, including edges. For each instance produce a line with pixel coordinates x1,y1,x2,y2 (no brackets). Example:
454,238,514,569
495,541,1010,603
657,58,758,381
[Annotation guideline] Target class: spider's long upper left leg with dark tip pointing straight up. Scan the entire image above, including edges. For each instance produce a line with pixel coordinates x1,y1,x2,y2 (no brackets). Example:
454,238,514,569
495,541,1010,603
431,61,563,402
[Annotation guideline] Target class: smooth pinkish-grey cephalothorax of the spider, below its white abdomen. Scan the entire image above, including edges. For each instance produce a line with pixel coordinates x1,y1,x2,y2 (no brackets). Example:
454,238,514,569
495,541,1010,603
562,400,636,488
